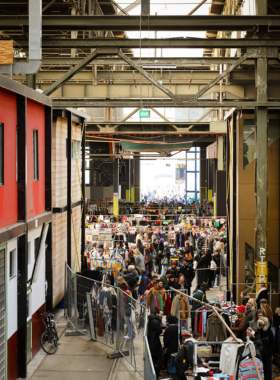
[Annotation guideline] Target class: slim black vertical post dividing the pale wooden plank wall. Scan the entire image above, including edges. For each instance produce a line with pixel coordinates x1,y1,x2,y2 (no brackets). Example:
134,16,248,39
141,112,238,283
67,112,72,268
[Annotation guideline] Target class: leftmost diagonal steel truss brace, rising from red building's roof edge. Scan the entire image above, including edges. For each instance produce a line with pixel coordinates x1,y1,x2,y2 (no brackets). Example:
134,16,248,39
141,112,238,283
44,48,117,96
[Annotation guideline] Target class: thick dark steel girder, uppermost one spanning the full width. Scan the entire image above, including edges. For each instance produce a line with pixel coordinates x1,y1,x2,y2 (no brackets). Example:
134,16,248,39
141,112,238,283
0,15,280,31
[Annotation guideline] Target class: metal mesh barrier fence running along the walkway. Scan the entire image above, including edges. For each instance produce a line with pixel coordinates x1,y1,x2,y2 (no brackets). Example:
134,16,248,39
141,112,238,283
64,265,156,380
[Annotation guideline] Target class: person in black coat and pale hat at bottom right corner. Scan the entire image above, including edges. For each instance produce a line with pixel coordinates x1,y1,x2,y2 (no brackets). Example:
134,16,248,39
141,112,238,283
257,317,274,380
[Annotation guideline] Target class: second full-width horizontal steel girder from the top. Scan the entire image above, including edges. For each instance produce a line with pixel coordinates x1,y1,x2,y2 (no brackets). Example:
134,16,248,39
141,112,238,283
16,37,280,49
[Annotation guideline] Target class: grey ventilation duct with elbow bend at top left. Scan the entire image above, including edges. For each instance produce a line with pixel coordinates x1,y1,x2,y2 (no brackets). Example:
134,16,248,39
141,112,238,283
0,0,42,75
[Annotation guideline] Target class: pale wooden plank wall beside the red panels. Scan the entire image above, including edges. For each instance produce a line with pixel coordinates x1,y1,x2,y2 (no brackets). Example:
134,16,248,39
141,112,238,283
52,117,81,306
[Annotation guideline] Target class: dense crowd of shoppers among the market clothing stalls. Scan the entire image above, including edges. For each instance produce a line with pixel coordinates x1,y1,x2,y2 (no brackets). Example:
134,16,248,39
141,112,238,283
84,217,280,380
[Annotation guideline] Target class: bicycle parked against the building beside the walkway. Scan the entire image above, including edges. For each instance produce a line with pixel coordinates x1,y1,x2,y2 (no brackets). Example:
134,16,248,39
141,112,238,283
37,310,59,355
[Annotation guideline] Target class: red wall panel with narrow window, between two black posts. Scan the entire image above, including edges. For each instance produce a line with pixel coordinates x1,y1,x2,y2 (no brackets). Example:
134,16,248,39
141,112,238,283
27,100,46,219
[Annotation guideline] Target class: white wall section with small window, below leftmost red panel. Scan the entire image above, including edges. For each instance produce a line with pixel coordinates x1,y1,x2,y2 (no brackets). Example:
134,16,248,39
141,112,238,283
6,239,18,339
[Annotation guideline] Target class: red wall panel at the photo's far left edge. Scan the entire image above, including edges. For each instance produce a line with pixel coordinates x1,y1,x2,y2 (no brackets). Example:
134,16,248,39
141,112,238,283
0,88,17,228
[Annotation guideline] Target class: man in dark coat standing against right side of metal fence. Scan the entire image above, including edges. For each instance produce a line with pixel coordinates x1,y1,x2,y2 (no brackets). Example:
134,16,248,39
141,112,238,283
148,308,163,372
